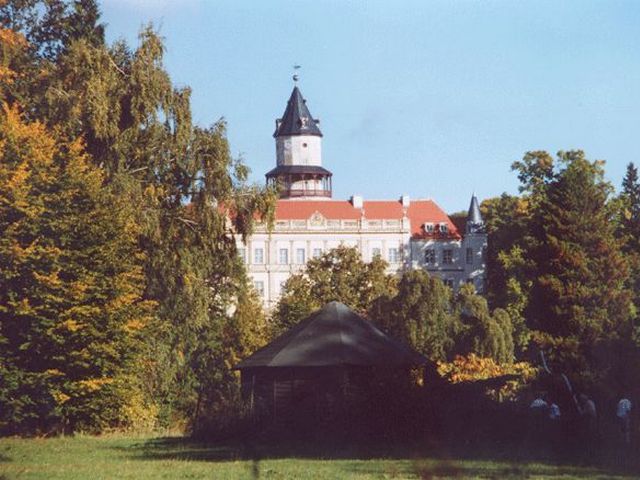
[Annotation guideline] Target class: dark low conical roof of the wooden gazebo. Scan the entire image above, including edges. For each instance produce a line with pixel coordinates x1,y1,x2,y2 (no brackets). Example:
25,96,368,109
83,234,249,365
236,302,428,370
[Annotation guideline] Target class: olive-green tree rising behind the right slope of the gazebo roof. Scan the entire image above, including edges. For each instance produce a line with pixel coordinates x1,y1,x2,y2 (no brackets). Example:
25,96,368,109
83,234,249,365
370,270,458,361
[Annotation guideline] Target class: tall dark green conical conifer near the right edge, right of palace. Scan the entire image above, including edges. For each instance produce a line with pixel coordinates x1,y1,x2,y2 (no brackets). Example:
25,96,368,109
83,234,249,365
529,152,631,343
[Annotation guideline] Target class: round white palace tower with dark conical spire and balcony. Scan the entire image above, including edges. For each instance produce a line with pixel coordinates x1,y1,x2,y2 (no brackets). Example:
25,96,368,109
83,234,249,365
266,86,332,200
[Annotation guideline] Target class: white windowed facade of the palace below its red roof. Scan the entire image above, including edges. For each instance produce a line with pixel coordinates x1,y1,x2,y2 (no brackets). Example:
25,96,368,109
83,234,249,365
238,200,486,308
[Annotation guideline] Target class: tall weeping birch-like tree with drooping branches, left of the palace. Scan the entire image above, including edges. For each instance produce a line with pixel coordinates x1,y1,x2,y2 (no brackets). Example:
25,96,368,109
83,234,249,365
0,0,275,432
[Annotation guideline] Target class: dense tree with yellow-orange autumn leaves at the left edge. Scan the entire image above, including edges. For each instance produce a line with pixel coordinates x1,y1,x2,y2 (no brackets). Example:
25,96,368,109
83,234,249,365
0,104,154,432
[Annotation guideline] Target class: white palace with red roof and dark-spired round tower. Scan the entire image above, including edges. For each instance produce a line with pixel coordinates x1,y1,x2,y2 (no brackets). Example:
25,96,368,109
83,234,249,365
238,86,487,308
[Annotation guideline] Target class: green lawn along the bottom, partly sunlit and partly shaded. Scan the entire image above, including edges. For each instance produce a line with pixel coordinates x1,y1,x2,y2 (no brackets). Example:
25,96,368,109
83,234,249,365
0,435,638,480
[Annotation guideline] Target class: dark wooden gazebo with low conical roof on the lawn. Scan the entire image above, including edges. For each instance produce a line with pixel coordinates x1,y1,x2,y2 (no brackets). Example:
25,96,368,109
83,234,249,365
236,302,428,423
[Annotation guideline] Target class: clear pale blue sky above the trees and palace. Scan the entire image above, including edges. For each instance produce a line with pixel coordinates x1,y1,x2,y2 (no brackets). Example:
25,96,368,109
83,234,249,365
101,0,640,212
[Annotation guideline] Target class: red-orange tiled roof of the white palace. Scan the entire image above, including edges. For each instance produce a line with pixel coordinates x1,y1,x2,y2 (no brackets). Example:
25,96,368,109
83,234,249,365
276,200,460,238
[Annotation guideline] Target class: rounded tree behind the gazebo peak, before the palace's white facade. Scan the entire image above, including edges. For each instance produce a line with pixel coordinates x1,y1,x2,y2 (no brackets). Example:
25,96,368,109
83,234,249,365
273,246,394,332
